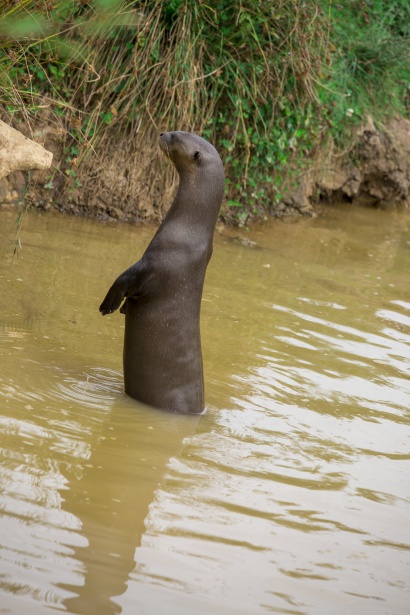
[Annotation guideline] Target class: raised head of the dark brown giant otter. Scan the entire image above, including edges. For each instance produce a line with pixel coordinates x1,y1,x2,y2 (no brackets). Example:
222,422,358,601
160,130,223,175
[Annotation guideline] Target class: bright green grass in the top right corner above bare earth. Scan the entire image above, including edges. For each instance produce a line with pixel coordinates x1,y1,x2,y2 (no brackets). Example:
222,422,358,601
318,0,410,141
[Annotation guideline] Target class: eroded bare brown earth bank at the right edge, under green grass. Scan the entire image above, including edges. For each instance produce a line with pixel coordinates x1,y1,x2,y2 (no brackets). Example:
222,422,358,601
279,117,410,215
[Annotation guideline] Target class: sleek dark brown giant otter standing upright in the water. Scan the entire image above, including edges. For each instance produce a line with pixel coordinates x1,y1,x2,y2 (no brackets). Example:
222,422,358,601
100,131,224,414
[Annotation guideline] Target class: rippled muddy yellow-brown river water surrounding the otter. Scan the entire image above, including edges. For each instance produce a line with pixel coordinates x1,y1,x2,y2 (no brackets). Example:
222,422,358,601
0,206,410,615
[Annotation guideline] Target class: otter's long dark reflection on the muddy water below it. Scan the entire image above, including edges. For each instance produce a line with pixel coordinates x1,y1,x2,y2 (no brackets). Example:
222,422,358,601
53,370,198,615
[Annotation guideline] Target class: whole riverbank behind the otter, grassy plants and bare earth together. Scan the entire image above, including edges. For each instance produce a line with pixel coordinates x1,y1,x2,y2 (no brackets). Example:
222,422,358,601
0,0,410,226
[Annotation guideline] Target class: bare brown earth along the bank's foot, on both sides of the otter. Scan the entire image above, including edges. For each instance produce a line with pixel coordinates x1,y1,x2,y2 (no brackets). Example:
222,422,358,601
0,118,410,223
